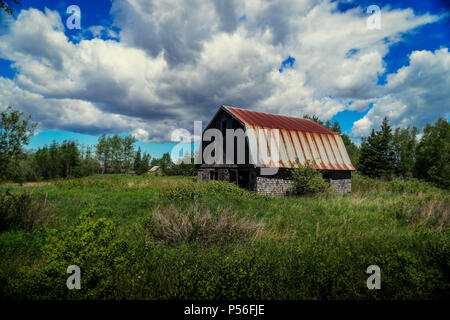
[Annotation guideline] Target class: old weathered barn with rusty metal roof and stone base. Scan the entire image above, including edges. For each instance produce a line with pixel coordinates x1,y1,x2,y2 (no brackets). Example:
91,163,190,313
197,106,355,195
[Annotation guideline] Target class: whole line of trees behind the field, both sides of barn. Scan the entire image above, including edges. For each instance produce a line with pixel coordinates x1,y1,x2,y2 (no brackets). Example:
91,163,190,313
0,107,450,188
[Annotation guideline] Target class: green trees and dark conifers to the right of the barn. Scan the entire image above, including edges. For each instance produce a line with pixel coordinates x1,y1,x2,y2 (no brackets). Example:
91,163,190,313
304,115,450,188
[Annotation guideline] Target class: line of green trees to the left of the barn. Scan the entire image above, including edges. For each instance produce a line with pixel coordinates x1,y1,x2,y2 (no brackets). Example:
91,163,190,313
0,107,195,182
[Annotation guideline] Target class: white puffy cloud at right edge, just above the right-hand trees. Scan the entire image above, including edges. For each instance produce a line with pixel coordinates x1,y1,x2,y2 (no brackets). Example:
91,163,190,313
352,48,450,138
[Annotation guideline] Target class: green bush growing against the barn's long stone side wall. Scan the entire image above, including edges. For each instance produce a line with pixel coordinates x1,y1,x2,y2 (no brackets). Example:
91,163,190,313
292,163,329,195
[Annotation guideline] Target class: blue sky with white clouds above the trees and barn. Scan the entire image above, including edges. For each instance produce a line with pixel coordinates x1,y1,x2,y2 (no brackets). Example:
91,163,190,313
0,0,450,157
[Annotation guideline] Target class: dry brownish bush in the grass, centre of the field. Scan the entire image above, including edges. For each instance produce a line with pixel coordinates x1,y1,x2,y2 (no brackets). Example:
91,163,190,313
144,206,262,245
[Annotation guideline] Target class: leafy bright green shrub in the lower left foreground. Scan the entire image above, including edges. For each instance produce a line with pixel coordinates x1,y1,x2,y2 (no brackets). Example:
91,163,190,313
35,209,133,299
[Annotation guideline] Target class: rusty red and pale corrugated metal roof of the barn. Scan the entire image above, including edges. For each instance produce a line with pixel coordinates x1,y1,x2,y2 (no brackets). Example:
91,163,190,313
222,106,355,170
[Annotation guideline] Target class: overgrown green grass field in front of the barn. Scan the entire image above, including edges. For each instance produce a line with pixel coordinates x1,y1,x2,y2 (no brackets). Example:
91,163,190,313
0,175,450,299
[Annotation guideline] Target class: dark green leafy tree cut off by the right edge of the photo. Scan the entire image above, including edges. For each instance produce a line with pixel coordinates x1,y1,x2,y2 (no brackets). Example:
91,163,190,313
415,118,450,189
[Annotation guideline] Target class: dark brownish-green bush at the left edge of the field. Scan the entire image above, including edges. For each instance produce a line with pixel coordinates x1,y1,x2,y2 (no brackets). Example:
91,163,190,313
0,190,51,232
